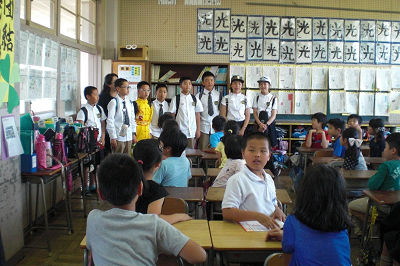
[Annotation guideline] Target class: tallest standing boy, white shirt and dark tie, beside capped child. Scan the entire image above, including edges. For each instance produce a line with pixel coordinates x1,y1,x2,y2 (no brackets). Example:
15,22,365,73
196,71,222,151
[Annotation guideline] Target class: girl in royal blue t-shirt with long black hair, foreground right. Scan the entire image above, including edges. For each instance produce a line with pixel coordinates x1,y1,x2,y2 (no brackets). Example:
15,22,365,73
267,165,351,265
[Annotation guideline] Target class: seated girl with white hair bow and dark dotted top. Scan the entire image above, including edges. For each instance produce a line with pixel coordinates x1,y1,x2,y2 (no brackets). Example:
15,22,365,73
340,127,368,170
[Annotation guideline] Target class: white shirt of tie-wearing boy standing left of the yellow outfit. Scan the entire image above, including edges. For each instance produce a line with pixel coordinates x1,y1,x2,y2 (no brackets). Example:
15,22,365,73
107,95,136,142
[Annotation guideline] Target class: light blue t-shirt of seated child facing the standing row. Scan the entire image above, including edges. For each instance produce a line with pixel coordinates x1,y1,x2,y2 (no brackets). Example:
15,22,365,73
153,156,192,187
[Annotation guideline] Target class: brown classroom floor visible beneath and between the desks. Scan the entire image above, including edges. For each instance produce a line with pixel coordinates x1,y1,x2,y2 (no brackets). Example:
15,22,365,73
17,176,370,266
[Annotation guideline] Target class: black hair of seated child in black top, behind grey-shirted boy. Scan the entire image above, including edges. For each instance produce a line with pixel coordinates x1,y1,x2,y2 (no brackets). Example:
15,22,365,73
133,139,162,172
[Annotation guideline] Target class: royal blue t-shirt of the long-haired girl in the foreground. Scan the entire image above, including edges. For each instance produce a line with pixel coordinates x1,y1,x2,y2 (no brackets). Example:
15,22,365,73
282,215,351,266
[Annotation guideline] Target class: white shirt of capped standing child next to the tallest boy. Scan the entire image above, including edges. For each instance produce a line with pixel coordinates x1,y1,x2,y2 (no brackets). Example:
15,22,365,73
222,93,250,122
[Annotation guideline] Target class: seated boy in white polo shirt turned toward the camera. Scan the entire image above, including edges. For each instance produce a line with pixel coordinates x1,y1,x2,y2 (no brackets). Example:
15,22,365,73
222,132,286,228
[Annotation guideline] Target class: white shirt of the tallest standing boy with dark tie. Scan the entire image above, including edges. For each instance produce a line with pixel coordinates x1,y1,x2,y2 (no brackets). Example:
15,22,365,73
196,88,220,134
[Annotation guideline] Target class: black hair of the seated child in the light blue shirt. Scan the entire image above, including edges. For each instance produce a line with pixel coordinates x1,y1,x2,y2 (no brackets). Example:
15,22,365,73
158,128,188,157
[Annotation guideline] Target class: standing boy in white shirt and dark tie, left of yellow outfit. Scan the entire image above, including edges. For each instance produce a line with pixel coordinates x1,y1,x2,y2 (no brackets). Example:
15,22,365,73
107,78,136,154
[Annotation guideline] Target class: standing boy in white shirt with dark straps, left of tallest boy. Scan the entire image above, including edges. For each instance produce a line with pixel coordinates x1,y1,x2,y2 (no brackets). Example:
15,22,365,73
169,77,203,149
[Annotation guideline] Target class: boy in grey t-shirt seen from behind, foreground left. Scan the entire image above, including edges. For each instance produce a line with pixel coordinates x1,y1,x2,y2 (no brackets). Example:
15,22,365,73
86,154,206,266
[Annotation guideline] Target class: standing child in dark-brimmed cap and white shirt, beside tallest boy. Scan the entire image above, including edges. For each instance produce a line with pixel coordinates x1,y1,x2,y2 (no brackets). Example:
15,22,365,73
221,75,250,136
